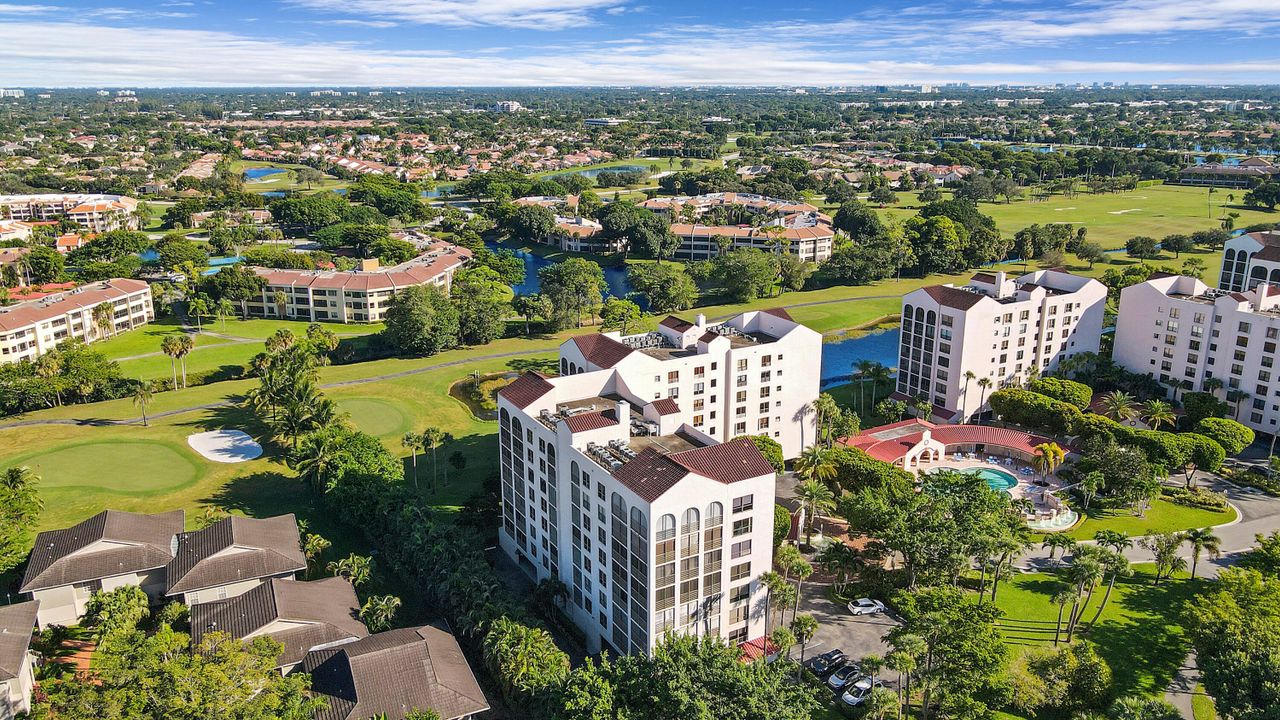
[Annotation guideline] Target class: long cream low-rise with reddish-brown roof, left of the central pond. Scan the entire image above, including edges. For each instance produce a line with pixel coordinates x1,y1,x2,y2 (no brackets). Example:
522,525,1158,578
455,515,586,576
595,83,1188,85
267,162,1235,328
247,242,471,323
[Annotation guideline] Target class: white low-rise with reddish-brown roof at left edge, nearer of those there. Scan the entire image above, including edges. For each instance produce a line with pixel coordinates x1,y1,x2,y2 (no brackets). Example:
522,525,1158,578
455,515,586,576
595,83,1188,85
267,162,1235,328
0,278,155,363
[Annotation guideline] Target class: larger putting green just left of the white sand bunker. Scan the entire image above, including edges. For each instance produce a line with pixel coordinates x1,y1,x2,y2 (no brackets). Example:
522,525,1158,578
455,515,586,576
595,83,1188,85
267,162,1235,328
13,441,201,495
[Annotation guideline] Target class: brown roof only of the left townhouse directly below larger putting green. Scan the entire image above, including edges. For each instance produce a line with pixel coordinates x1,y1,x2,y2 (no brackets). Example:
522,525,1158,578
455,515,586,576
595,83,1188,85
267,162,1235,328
18,510,186,592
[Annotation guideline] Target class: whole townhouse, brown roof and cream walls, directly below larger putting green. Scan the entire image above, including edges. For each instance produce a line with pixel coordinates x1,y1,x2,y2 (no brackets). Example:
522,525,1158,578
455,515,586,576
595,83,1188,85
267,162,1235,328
18,510,186,628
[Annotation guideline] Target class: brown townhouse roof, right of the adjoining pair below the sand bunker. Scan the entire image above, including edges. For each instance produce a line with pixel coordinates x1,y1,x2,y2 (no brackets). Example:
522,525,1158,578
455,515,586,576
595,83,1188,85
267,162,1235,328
165,512,307,594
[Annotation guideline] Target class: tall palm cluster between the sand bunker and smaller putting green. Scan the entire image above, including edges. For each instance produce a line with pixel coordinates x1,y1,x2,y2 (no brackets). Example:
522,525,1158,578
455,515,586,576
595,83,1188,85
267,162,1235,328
246,325,338,450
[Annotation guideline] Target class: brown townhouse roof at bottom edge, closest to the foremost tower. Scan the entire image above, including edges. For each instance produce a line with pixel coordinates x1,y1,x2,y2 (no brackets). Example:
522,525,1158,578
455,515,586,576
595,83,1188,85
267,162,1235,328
303,625,489,720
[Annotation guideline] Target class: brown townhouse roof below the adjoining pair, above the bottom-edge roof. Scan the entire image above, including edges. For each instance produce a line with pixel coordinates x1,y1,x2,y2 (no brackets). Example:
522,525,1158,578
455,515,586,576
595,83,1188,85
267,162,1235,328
191,578,369,666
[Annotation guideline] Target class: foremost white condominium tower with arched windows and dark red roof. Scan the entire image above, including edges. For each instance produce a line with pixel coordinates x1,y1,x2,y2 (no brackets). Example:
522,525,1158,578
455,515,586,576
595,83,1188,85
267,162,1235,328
498,369,776,653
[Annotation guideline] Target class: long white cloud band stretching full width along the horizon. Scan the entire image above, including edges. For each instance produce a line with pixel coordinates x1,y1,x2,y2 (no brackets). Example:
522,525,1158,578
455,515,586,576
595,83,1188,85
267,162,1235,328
0,22,1280,87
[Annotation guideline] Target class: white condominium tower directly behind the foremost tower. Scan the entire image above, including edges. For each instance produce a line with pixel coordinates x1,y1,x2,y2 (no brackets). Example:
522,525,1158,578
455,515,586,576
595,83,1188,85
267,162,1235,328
559,309,822,457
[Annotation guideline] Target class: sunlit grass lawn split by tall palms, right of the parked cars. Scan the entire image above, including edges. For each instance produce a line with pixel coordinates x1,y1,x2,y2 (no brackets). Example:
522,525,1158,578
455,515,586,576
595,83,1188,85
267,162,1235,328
996,564,1201,696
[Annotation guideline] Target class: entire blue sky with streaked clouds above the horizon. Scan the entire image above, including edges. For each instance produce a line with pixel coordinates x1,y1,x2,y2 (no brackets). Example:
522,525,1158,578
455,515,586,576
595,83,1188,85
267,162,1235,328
0,0,1280,87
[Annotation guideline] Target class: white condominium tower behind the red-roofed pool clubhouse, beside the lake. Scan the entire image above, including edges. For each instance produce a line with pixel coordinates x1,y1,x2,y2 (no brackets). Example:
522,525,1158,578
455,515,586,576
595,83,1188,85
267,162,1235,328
897,270,1107,423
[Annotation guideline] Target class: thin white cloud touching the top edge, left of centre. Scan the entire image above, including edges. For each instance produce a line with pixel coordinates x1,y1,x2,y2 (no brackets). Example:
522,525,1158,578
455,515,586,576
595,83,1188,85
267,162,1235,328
285,0,625,29
